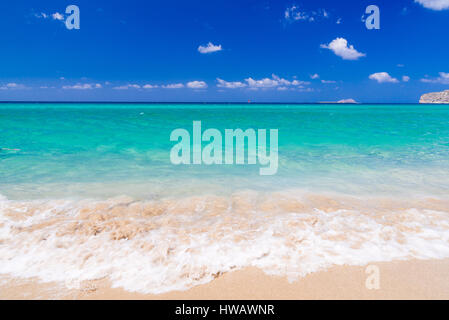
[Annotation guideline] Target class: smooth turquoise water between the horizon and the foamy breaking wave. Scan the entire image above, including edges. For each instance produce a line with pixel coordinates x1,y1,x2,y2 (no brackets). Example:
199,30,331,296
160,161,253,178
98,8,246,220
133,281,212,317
0,104,449,199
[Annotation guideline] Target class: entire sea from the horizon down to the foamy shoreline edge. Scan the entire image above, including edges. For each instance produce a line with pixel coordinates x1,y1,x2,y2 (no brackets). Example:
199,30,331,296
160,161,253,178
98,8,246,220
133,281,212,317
0,104,449,293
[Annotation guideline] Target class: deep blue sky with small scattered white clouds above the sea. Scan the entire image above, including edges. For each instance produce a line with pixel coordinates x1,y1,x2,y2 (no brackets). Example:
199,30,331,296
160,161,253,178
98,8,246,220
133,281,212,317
0,0,449,103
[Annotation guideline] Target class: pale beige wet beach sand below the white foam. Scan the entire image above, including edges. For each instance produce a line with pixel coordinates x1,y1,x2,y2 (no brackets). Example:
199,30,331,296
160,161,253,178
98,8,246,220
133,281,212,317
0,259,449,300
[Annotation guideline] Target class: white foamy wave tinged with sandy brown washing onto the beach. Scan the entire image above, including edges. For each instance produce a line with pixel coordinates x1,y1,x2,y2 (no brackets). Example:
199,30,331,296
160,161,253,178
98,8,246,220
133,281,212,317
0,190,449,294
